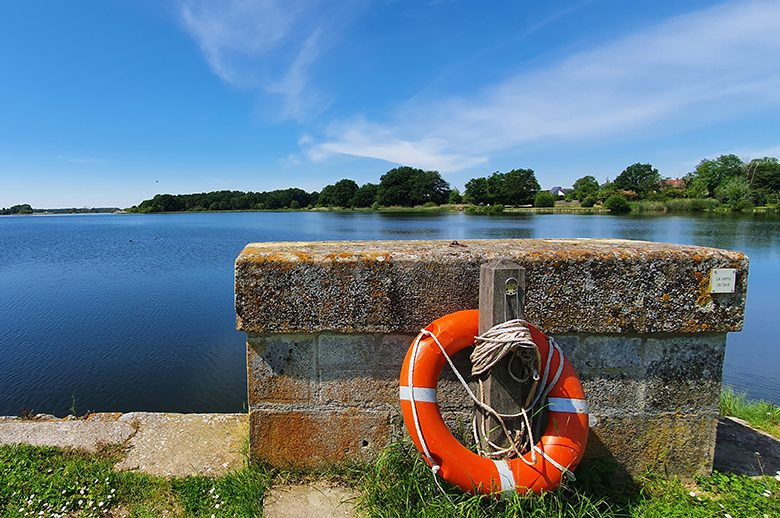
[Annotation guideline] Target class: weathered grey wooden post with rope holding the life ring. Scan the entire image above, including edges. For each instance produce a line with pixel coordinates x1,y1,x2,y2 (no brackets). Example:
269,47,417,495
479,260,525,446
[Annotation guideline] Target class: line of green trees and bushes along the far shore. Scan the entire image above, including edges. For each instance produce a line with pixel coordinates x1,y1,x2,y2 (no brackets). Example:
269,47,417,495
6,155,780,215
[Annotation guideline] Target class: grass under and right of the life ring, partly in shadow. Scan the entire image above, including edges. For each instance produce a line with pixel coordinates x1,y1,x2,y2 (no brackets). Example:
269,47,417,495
358,442,780,518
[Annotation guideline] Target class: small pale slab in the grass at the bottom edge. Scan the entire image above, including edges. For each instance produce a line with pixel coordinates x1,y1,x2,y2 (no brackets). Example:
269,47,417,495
263,482,357,518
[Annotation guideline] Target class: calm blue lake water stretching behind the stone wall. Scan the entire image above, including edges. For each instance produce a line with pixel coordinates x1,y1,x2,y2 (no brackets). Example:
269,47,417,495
0,212,780,415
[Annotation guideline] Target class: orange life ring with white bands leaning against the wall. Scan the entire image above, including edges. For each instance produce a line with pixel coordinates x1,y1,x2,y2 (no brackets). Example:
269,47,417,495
400,310,588,494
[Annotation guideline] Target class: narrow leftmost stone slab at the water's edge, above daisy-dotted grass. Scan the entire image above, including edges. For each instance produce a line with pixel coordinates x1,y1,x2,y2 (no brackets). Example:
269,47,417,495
0,414,135,452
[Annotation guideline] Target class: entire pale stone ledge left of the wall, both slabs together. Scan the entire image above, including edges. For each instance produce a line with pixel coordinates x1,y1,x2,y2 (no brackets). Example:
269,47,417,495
0,412,249,477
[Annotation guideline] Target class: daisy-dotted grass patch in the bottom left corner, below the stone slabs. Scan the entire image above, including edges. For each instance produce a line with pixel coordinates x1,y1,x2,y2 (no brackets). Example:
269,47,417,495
0,445,271,517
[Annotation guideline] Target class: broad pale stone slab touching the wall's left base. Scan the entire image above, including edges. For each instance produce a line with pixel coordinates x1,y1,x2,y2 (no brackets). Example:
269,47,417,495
116,412,249,477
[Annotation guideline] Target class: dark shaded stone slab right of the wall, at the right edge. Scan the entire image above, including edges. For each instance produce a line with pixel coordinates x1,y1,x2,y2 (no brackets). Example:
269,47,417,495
713,417,780,476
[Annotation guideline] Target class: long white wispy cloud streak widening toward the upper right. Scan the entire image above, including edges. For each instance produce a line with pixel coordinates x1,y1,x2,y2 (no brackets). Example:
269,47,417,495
306,1,780,172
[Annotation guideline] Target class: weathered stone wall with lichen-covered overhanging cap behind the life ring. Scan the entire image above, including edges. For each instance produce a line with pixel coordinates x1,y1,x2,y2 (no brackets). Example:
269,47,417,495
236,240,747,476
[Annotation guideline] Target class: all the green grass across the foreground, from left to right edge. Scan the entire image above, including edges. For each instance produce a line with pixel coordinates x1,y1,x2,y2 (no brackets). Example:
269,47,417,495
0,440,780,518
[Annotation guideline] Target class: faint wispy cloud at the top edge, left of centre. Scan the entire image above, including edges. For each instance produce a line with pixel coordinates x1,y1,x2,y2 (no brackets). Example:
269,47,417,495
179,0,362,119
